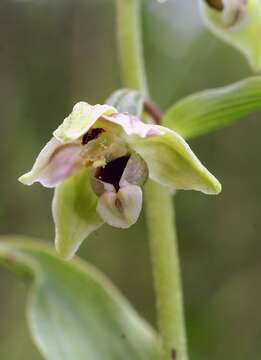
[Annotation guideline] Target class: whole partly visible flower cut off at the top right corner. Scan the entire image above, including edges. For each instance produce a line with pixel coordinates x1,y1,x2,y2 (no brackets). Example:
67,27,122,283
199,0,261,71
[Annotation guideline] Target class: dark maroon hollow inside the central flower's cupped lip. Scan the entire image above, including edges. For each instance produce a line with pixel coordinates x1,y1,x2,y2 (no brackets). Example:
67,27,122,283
95,155,130,191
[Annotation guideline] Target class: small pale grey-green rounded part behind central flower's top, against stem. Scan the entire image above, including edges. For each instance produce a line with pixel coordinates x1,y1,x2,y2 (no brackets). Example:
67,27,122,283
106,89,144,117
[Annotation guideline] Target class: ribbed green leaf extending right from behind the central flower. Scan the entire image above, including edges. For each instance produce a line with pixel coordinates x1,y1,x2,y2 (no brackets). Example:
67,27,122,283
162,76,261,139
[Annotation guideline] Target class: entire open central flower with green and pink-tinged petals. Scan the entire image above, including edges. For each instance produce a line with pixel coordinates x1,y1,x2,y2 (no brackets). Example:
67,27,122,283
19,102,221,258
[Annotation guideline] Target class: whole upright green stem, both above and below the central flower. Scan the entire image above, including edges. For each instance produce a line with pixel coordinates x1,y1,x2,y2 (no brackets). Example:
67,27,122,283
116,0,188,360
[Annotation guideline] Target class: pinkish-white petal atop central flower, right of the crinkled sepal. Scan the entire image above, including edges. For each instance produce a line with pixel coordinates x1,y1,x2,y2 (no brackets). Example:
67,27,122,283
103,113,161,138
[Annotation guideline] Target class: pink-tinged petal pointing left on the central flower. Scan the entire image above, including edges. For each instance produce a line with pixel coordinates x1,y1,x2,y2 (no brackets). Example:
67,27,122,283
19,138,81,187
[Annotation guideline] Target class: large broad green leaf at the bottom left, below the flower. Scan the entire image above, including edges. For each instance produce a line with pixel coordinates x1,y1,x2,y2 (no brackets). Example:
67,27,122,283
0,237,162,360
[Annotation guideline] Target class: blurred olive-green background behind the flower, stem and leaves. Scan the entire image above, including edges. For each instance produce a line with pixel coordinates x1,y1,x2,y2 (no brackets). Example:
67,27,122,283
0,0,261,360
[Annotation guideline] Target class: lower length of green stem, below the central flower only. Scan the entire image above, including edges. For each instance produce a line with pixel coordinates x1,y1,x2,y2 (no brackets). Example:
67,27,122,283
145,181,188,360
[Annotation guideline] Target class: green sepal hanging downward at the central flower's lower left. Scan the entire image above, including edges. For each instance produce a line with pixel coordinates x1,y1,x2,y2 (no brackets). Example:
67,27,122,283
52,168,102,259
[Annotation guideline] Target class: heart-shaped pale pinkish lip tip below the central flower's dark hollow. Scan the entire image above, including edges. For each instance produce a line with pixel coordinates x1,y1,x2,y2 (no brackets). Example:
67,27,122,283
97,185,142,229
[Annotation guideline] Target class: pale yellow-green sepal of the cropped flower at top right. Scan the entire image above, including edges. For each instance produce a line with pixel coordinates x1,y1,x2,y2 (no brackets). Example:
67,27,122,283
200,0,261,71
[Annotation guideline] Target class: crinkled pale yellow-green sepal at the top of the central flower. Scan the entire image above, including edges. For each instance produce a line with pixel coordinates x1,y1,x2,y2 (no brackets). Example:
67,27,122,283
53,101,117,143
